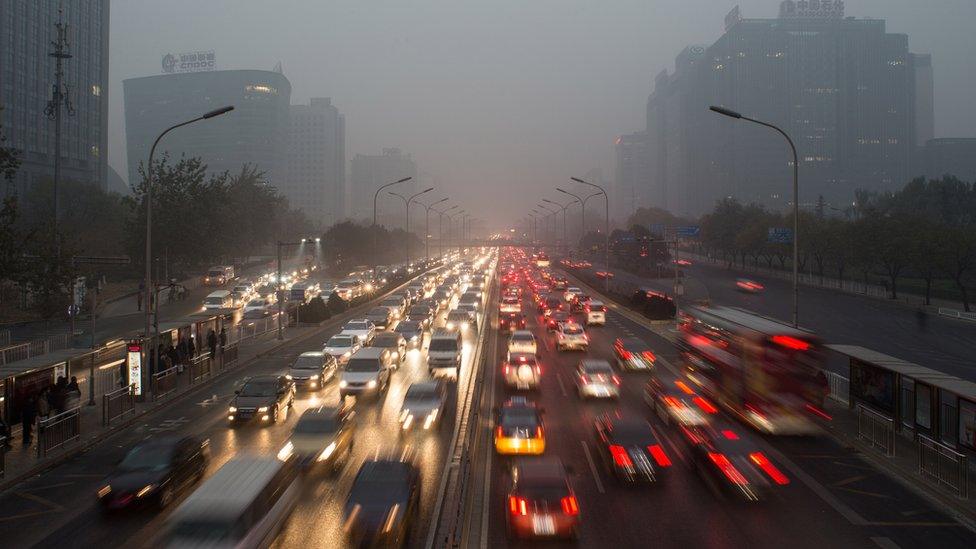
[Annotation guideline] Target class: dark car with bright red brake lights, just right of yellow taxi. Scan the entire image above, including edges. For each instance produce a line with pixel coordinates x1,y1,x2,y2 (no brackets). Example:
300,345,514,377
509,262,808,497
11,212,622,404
594,415,673,484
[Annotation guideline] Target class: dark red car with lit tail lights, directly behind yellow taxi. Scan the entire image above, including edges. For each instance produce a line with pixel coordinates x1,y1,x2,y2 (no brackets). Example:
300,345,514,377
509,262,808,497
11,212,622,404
505,458,580,539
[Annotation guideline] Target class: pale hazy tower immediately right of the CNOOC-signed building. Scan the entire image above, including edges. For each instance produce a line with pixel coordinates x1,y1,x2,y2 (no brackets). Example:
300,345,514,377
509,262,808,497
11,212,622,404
278,97,346,227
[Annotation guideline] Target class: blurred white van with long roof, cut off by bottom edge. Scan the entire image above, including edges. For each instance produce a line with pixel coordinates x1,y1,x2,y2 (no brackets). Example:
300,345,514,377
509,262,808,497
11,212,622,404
166,456,300,548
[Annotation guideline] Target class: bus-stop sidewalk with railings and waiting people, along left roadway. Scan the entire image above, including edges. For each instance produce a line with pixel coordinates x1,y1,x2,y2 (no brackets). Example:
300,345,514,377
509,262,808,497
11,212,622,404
0,325,320,490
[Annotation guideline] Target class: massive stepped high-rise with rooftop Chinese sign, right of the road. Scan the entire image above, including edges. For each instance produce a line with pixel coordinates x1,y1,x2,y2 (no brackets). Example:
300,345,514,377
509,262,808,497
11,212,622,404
647,0,916,215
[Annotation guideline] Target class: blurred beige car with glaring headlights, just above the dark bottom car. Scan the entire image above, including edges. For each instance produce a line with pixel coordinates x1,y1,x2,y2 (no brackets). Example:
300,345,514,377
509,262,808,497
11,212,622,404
278,405,356,473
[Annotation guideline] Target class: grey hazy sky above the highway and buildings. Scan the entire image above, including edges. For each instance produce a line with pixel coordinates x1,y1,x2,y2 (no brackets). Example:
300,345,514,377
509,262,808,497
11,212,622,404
109,0,976,223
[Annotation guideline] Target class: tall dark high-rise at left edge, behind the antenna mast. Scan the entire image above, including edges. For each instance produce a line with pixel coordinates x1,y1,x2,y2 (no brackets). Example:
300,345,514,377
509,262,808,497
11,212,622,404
0,0,109,193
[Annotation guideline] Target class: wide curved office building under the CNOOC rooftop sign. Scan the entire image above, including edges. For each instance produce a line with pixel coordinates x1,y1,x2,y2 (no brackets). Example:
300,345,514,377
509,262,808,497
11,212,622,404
123,70,291,185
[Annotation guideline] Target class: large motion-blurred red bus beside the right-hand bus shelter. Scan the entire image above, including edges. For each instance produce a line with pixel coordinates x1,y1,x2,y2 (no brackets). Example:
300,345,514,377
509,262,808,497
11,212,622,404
678,306,827,435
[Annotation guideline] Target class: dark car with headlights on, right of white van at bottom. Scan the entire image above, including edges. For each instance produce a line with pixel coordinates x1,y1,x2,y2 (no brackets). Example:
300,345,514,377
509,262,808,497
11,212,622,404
342,459,421,547
